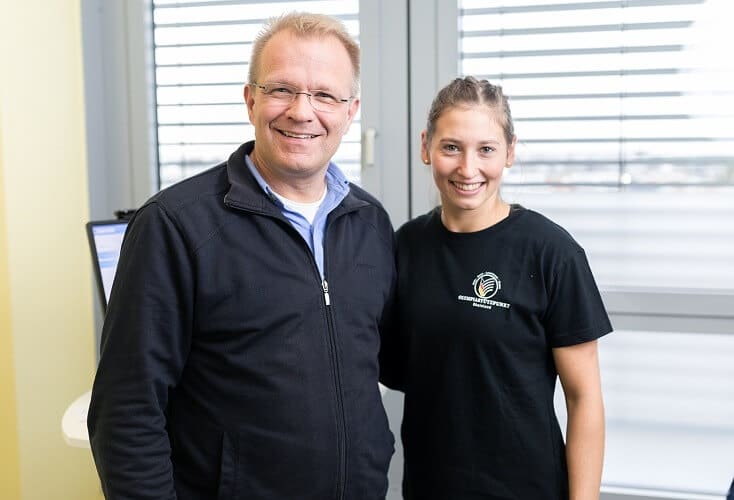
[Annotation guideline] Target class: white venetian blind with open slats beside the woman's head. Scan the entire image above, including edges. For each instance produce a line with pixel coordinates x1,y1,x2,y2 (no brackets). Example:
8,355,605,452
459,0,734,187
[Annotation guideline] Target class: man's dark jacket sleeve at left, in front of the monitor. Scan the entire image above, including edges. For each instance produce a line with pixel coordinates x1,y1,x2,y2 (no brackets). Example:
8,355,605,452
87,202,194,500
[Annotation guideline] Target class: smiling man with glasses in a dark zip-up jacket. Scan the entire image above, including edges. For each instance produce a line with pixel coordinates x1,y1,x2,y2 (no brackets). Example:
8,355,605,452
88,14,395,500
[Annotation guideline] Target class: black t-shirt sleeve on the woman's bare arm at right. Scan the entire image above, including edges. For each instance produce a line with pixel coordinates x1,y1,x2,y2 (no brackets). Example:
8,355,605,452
544,248,612,347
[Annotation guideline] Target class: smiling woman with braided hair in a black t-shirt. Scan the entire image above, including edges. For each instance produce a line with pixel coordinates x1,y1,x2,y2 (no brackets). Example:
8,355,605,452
383,77,612,500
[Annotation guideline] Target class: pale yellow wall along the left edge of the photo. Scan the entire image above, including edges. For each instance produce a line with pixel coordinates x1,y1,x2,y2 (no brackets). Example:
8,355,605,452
0,0,100,500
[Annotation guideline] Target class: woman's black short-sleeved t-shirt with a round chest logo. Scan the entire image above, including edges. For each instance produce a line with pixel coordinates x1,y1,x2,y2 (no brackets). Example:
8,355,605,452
388,205,612,500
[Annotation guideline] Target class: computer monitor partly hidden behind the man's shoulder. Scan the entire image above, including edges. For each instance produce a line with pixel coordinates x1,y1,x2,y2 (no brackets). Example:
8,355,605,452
86,219,128,313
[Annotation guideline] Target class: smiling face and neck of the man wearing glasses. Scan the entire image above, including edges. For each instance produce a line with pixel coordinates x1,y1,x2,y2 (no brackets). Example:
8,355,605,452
245,30,359,187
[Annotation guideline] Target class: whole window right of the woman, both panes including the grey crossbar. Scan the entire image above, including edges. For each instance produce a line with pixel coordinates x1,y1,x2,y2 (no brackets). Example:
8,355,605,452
458,0,734,499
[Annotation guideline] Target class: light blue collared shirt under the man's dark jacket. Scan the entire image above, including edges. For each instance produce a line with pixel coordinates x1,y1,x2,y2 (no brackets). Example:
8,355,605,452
245,156,349,279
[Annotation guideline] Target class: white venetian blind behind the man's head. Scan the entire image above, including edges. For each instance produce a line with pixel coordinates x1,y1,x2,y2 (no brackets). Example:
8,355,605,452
153,0,360,188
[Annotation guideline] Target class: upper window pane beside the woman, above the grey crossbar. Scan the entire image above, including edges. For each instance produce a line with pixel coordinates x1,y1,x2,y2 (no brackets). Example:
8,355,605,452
458,0,734,290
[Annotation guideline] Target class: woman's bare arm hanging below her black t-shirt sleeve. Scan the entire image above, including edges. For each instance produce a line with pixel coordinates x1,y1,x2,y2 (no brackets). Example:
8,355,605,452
553,340,604,500
